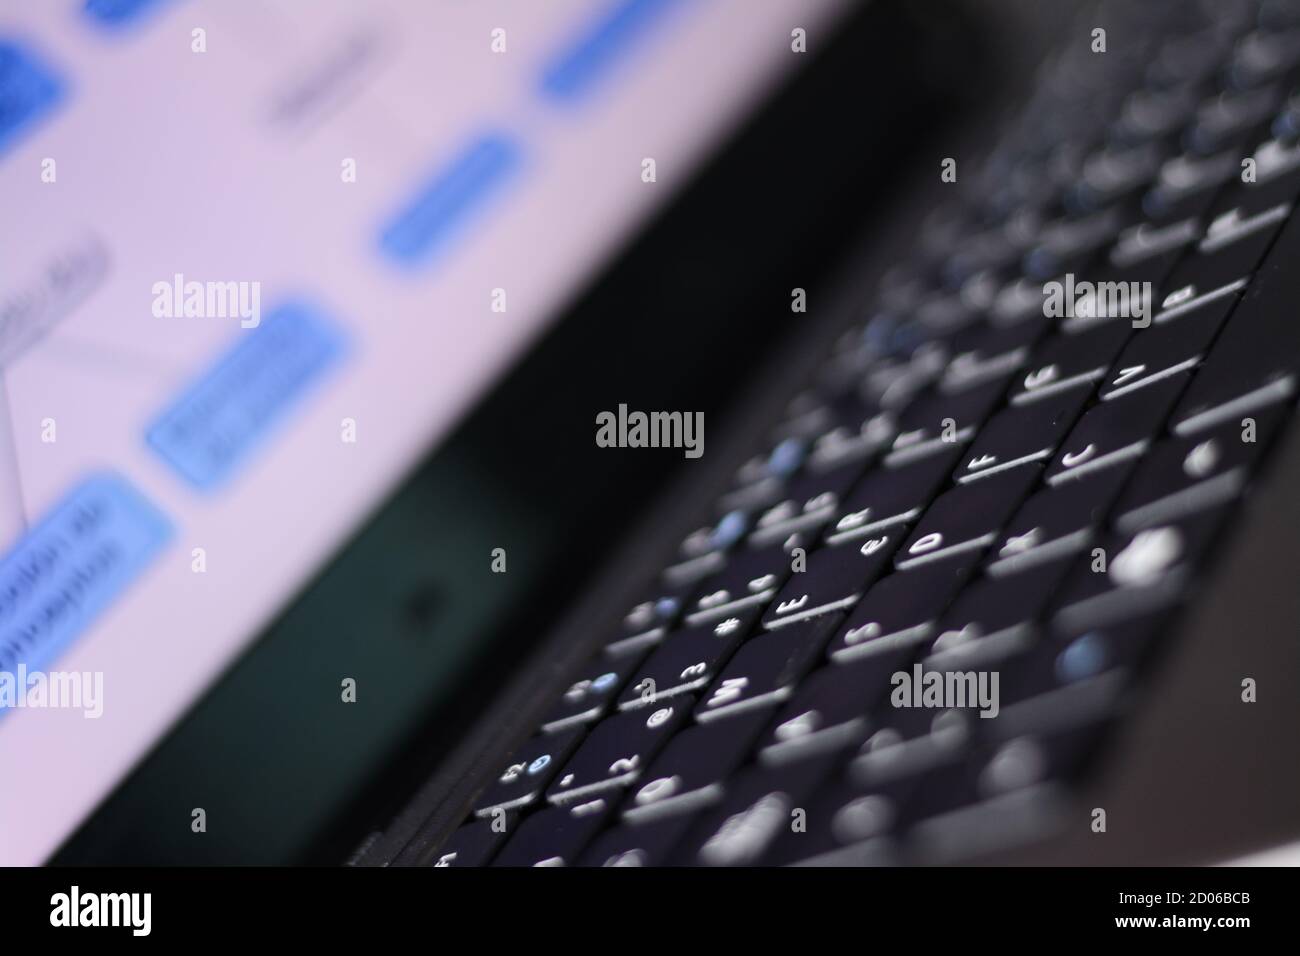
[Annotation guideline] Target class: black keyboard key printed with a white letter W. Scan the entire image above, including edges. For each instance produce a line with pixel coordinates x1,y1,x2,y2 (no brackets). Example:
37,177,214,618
696,615,839,721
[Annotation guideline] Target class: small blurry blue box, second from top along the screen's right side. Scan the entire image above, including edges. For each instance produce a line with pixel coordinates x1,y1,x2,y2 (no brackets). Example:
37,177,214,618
380,133,523,265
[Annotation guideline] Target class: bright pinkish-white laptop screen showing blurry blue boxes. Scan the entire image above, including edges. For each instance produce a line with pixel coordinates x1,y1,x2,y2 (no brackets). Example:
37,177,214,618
0,0,842,864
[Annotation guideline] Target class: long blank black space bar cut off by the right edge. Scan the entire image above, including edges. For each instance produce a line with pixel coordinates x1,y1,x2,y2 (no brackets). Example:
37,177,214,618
1174,217,1300,434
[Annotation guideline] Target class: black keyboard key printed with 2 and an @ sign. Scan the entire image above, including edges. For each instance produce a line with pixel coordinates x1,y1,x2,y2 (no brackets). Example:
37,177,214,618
546,696,694,804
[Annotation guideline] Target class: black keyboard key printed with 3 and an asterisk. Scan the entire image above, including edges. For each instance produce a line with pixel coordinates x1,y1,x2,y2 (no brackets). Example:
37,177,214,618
619,607,758,710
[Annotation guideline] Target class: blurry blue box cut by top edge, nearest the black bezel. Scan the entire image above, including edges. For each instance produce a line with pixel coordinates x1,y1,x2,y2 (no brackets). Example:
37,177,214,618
541,0,684,101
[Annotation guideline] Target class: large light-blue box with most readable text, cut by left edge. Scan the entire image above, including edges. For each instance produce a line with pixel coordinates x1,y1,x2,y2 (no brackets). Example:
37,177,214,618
0,472,172,674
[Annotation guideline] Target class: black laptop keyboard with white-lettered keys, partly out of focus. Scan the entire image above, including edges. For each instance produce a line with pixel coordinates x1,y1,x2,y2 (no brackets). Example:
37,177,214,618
432,1,1300,866
